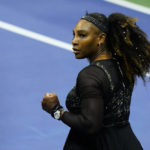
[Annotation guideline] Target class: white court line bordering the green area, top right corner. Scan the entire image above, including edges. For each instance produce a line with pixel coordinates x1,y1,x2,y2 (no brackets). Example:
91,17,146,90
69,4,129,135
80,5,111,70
104,0,150,15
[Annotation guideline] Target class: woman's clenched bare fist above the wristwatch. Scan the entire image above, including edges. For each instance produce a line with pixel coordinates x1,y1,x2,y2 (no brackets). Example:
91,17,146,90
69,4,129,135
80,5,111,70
42,93,59,113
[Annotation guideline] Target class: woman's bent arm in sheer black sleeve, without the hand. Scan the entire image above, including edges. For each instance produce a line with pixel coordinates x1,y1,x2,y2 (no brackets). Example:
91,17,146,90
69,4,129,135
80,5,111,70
61,66,105,134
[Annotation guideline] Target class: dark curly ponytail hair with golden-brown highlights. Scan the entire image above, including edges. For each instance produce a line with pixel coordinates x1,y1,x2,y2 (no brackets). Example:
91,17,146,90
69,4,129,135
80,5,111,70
86,13,150,83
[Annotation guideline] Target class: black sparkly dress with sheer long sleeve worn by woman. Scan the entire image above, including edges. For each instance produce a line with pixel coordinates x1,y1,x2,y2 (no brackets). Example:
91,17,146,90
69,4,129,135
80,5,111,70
61,59,142,150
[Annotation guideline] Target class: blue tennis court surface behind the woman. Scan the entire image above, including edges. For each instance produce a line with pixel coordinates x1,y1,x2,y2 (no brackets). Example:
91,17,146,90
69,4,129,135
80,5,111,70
0,0,150,150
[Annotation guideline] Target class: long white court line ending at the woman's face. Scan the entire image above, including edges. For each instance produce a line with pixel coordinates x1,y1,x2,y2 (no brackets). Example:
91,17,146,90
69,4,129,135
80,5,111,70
0,21,72,51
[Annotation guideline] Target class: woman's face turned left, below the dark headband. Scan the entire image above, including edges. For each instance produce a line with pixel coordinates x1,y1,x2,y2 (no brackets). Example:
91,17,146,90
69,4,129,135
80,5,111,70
72,19,100,59
